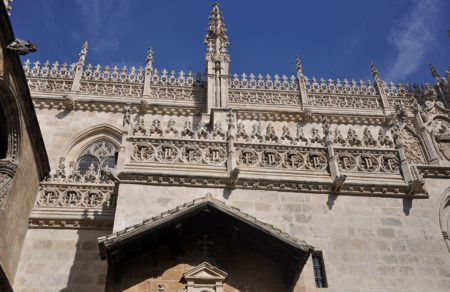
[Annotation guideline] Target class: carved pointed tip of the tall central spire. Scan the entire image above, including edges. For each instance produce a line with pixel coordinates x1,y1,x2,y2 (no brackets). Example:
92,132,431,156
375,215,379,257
205,2,229,57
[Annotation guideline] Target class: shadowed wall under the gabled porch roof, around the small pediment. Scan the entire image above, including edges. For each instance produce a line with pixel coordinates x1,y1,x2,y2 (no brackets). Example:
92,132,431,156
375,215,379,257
106,230,299,292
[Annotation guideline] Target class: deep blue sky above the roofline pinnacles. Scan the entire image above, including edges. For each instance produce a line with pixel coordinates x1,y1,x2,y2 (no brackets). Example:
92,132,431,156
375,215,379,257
11,0,450,83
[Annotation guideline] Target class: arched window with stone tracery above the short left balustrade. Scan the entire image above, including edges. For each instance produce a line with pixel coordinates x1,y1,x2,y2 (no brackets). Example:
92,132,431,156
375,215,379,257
77,141,117,174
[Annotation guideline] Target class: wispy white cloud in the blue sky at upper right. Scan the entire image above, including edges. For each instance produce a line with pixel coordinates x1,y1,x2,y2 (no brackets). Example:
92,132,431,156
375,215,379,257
386,0,440,81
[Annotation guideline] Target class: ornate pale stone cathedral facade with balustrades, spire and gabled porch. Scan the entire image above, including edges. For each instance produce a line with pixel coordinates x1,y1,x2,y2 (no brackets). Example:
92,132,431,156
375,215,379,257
0,4,450,292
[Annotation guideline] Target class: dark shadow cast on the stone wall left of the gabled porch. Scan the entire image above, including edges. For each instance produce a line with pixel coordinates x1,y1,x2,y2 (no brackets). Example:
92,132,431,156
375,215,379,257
59,210,112,292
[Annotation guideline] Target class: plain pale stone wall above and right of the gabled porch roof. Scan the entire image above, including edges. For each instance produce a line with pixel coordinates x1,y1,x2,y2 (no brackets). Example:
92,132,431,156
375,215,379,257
114,179,450,291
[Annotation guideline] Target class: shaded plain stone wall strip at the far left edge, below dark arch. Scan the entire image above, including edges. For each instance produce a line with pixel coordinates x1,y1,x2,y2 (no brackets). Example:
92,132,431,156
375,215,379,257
0,122,39,283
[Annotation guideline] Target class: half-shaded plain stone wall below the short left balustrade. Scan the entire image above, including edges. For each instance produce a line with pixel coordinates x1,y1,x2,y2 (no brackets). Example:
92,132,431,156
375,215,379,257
14,229,110,292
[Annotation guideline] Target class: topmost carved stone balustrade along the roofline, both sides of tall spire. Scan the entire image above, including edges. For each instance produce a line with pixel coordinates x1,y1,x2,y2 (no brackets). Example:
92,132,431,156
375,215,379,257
23,60,437,112
